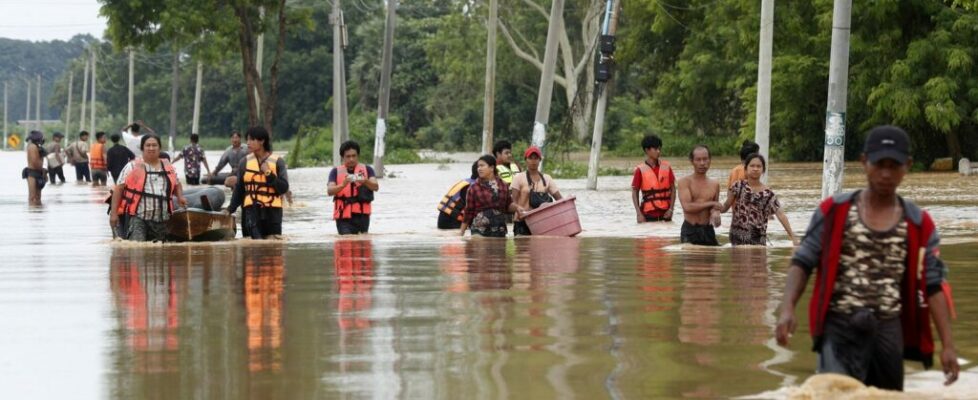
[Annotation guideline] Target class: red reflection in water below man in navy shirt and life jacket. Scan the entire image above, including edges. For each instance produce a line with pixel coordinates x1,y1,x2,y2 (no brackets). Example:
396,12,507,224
333,240,374,330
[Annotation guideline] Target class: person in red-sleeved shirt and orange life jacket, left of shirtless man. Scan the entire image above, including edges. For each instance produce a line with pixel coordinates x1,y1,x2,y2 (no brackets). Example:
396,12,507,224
632,135,676,224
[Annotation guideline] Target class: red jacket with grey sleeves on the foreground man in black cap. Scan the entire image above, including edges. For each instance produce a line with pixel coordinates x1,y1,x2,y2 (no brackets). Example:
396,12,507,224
791,191,953,368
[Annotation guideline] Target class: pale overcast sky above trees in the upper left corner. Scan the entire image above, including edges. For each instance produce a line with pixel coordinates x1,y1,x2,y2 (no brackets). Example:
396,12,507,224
0,0,105,41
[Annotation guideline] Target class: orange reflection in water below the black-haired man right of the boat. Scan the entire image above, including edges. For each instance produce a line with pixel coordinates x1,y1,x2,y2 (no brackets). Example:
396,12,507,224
242,242,285,372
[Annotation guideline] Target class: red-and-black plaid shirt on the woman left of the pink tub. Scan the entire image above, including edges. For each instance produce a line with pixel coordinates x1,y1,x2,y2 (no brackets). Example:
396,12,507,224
464,178,513,237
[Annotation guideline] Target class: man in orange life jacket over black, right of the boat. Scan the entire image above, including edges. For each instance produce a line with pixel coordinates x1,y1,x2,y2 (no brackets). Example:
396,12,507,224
227,126,289,239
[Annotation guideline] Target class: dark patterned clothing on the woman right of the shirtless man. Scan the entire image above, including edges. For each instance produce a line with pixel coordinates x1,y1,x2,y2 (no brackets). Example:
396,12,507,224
730,180,781,246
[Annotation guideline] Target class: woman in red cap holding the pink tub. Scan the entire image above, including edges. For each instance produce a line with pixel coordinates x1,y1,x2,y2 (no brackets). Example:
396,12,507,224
509,146,561,236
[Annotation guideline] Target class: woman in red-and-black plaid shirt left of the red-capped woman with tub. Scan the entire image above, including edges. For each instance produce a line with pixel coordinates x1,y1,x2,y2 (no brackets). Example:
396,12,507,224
459,155,523,237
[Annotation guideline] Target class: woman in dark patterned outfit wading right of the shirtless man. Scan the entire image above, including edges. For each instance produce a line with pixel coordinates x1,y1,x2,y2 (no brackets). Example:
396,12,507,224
721,153,798,246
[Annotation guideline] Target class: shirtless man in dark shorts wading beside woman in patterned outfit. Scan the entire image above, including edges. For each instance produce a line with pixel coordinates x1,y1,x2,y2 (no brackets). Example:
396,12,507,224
678,145,722,246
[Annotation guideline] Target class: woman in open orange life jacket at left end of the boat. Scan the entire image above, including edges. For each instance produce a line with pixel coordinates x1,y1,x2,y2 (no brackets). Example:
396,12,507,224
109,135,187,241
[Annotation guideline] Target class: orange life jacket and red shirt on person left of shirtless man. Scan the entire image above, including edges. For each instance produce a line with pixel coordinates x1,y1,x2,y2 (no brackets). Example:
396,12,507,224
632,160,676,221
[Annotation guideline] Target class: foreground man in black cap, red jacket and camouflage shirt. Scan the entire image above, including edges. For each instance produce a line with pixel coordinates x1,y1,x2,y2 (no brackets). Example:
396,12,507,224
776,126,960,390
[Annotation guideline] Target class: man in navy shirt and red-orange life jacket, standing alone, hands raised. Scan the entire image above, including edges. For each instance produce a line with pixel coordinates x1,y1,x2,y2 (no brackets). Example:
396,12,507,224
326,140,380,235
